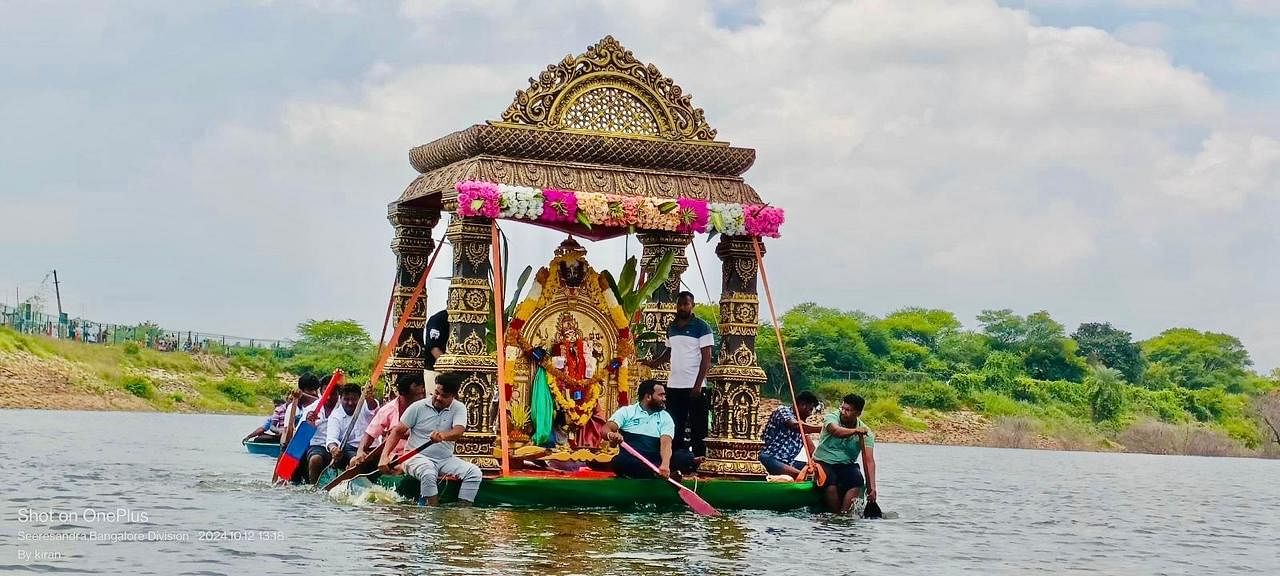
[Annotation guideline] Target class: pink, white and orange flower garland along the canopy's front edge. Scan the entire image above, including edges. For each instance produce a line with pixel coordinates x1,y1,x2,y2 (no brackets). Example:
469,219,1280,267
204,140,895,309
454,180,786,238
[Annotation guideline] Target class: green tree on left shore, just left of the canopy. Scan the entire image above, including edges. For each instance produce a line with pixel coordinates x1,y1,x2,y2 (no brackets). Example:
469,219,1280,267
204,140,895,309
288,320,376,380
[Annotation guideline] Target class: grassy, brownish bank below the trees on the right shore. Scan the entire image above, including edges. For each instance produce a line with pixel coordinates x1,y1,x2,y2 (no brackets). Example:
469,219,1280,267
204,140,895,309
815,379,1280,458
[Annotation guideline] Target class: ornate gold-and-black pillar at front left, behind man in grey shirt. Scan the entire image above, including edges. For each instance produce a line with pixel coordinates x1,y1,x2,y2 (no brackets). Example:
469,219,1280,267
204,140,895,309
435,216,498,470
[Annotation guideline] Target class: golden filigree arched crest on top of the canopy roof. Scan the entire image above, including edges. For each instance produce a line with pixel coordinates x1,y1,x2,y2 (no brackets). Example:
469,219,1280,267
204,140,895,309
502,36,716,142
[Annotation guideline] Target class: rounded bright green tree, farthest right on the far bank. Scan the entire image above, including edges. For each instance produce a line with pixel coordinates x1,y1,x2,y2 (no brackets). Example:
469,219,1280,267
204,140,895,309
1142,328,1253,392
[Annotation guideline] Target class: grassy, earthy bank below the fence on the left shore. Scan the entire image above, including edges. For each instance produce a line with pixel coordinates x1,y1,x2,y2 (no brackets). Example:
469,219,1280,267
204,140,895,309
0,323,292,413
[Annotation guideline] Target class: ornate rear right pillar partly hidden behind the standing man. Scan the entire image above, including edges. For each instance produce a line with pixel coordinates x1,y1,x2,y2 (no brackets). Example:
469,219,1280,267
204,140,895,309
627,232,694,386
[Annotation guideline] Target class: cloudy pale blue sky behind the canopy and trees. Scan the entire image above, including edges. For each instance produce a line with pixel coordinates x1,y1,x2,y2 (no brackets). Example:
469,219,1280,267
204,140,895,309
0,0,1280,372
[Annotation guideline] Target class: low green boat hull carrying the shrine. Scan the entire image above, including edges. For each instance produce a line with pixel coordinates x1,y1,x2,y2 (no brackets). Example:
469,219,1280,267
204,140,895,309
320,471,820,511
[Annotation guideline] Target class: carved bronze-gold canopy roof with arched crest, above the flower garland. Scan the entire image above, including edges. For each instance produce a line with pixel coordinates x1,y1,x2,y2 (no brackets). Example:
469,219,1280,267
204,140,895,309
398,36,760,210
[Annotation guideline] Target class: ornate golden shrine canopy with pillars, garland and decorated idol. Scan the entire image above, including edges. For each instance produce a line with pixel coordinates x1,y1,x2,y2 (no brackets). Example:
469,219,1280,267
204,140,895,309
388,36,782,477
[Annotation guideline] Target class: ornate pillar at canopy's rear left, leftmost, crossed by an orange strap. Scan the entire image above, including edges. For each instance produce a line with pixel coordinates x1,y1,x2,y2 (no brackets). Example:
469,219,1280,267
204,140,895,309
383,202,440,390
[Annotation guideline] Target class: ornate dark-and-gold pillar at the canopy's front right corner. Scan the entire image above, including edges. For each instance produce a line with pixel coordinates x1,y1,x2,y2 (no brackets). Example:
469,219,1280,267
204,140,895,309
701,236,765,476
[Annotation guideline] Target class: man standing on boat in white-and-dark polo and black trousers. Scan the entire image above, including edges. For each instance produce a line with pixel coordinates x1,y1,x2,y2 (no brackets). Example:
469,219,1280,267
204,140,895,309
644,292,716,458
